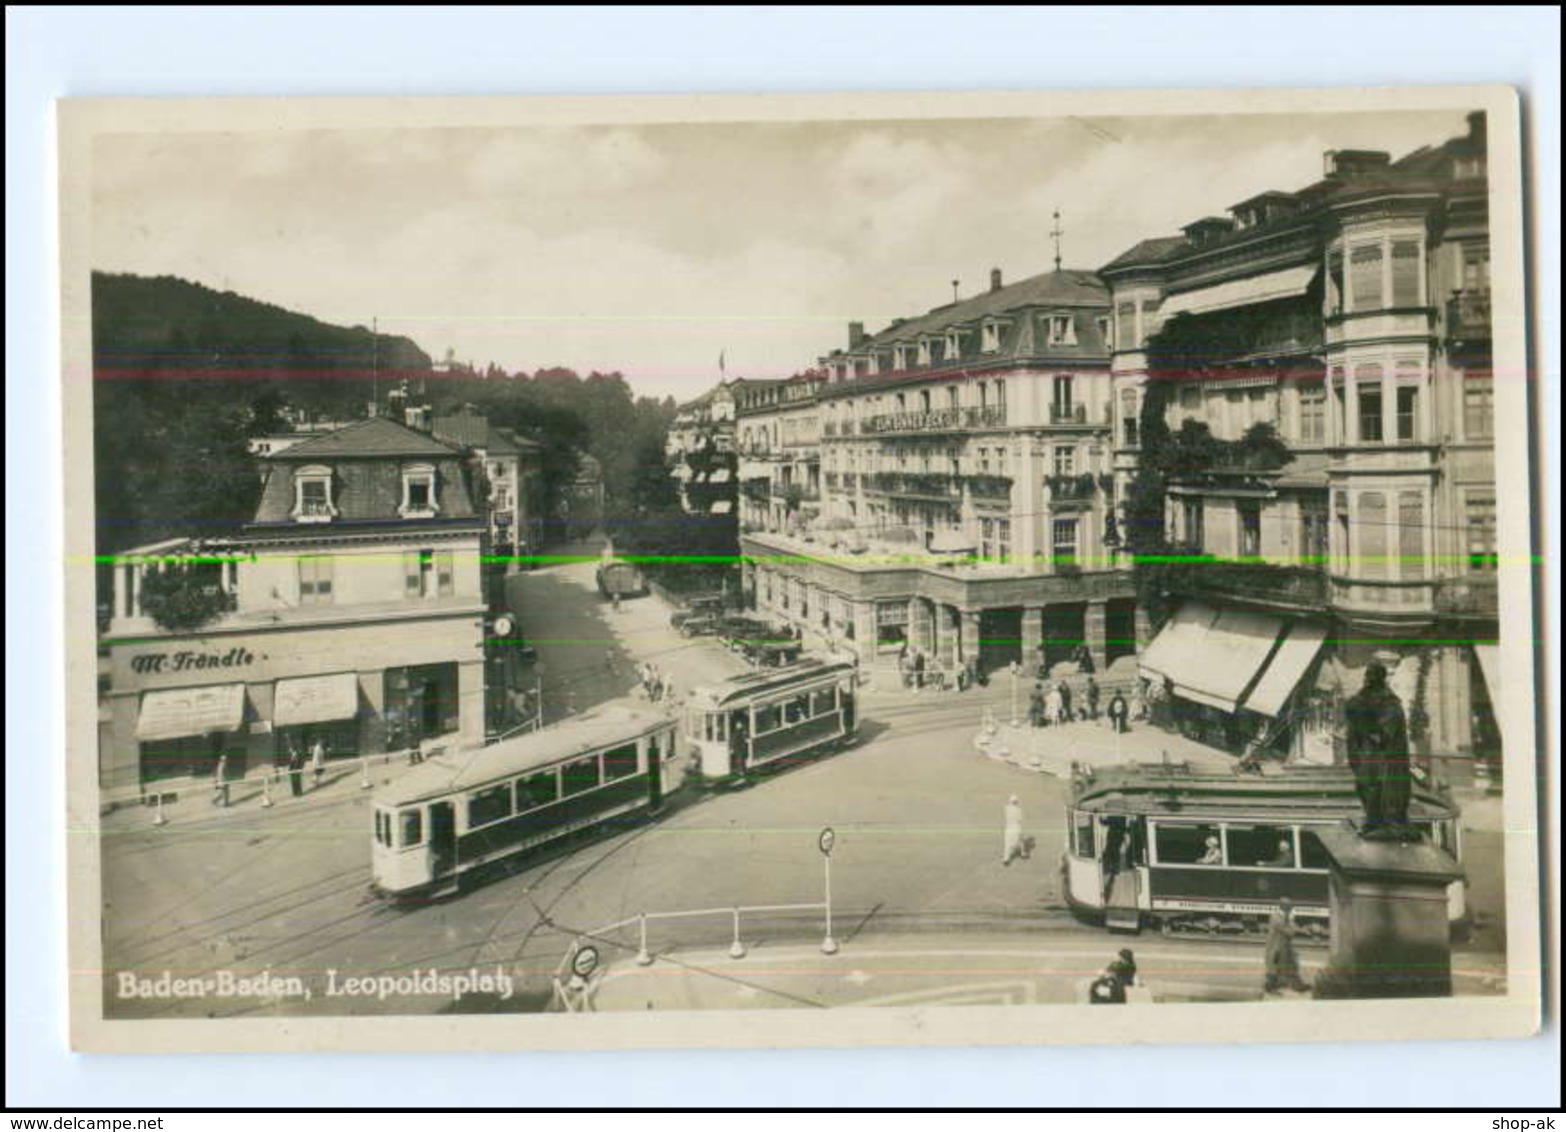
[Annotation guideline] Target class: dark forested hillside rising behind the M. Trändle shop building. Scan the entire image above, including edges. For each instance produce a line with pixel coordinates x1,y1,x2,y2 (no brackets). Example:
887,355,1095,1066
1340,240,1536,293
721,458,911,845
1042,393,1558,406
92,272,431,554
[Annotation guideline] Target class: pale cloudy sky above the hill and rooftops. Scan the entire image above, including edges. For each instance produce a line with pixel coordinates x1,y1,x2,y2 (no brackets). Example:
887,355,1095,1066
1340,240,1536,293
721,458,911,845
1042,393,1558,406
91,111,1464,399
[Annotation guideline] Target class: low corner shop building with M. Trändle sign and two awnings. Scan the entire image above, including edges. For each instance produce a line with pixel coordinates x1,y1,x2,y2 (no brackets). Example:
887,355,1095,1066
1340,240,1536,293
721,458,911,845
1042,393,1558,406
99,418,489,789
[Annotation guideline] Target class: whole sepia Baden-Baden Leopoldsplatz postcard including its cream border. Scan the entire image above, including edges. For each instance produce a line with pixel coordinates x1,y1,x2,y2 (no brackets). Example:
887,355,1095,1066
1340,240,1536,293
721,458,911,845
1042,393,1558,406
58,88,1553,1051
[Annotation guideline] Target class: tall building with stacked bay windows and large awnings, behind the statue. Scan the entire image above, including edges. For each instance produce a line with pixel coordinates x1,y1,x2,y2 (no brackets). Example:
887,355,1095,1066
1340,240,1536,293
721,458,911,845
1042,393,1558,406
1099,114,1499,762
